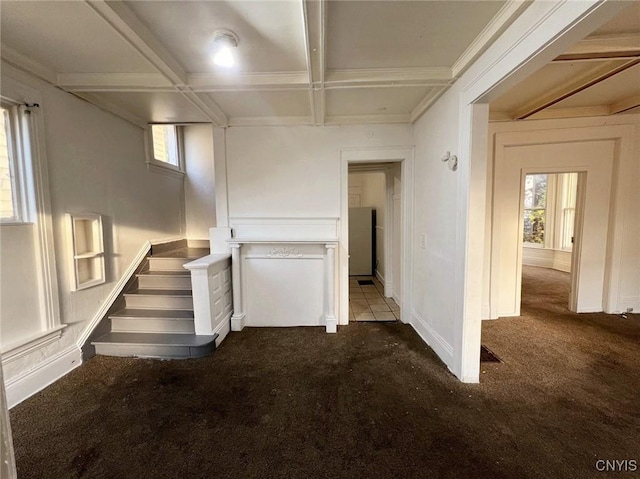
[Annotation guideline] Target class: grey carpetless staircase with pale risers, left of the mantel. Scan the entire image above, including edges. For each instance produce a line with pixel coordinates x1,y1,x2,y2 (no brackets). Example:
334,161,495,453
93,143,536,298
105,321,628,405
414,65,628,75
91,247,218,359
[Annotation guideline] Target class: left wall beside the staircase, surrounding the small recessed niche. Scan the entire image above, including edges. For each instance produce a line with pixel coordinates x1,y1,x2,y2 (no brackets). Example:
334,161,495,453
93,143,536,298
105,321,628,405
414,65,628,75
0,63,184,402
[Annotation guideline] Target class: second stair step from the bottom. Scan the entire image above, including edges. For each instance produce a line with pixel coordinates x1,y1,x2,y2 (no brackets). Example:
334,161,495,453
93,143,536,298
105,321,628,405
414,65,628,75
109,309,195,334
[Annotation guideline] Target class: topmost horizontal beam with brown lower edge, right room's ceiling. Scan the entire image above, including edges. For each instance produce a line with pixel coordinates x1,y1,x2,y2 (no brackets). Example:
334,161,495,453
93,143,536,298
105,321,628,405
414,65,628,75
554,33,640,62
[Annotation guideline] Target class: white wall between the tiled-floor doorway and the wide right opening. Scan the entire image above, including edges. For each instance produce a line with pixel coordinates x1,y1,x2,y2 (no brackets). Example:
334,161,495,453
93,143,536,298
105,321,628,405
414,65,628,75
411,85,460,367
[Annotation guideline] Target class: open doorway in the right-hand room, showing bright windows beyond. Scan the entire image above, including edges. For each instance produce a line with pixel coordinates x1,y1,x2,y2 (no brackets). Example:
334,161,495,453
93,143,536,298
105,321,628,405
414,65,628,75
521,172,582,312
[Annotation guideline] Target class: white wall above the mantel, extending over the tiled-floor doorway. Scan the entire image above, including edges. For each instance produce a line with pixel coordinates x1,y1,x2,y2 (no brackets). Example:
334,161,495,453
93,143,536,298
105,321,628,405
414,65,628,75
226,125,413,218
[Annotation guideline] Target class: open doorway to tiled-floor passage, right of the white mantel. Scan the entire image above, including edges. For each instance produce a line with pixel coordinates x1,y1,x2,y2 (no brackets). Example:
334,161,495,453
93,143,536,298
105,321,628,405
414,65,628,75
347,162,402,322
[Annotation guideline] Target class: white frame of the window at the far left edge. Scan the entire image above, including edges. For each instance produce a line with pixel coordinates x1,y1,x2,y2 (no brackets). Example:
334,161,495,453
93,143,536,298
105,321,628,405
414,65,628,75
0,101,34,226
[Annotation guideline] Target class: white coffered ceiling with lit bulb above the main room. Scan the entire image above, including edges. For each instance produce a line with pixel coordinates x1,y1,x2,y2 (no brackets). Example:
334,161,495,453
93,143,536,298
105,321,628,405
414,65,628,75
0,0,528,126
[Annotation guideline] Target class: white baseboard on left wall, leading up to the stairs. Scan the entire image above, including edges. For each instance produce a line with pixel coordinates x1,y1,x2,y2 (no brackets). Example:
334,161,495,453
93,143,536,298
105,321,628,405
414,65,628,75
6,344,82,409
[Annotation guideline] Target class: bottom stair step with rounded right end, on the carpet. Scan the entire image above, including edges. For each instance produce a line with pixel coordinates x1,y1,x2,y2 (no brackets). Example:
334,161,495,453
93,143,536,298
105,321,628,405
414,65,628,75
91,332,218,359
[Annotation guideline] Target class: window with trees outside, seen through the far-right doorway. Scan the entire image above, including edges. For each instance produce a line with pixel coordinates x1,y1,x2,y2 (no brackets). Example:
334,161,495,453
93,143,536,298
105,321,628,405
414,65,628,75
523,175,548,246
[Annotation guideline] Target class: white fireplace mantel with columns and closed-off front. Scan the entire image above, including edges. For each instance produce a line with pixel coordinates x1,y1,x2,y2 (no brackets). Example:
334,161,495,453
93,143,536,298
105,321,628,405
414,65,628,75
221,218,338,333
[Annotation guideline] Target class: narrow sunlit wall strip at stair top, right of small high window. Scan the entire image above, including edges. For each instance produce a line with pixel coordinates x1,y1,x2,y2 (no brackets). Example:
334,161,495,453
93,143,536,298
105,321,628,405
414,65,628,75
183,124,216,240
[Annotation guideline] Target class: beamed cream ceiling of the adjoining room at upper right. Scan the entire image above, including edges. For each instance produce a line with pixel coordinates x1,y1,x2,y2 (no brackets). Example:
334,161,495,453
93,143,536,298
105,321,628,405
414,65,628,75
491,1,640,120
